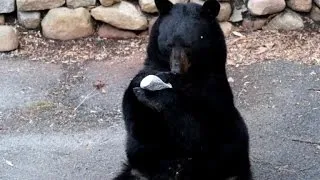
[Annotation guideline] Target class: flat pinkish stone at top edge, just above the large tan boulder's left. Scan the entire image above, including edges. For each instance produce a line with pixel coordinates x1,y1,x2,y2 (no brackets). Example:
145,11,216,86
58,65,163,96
16,0,65,11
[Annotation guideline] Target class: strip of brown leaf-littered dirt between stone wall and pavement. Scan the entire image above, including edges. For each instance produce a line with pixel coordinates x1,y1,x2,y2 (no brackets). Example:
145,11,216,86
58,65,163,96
0,22,320,66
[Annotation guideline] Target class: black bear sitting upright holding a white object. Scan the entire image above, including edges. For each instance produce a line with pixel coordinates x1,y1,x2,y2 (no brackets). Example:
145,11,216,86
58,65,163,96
115,0,252,180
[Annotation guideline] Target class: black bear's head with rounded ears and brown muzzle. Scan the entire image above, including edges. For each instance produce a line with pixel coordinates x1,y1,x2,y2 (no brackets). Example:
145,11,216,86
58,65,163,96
146,0,227,73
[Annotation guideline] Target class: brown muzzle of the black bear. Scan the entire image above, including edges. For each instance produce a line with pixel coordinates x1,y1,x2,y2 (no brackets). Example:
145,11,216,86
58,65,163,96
170,47,191,74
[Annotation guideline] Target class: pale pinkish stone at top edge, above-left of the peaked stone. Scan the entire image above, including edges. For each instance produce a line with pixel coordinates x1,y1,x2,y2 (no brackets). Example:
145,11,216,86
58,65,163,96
248,0,286,15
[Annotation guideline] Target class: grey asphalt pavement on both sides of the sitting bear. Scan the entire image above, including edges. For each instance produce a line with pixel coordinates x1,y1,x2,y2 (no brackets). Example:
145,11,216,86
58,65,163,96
0,58,320,180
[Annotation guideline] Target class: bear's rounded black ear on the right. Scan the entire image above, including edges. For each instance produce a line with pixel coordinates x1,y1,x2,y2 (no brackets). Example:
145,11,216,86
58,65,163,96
201,0,220,19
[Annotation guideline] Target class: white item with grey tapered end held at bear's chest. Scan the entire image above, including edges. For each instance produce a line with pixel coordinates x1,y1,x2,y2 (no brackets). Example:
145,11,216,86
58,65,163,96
140,75,172,91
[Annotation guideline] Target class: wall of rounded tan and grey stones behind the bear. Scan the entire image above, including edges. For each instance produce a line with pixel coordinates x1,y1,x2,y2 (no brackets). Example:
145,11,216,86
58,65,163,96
0,0,320,51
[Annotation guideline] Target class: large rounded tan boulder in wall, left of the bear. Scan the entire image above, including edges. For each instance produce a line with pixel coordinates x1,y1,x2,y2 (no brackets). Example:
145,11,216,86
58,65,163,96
41,7,94,40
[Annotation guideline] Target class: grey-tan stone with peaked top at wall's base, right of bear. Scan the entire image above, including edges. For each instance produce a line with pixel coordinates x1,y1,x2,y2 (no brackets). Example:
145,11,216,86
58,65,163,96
264,9,304,30
